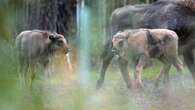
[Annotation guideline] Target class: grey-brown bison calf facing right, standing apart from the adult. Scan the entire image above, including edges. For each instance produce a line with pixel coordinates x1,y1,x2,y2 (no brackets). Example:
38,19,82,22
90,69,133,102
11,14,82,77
16,30,69,84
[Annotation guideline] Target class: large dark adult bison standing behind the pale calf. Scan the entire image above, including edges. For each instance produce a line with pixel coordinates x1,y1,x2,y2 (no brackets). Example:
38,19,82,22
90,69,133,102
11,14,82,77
97,0,195,88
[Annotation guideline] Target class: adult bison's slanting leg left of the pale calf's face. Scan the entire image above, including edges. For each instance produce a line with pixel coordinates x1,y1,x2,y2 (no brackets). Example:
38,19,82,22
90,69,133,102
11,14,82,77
96,49,114,89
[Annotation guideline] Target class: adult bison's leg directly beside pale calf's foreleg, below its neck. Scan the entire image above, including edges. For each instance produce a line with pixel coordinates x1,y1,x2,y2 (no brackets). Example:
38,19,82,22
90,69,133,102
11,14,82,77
118,58,131,88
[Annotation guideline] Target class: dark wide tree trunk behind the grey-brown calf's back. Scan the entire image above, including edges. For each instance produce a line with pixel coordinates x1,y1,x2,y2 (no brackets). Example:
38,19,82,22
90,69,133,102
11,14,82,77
17,0,76,37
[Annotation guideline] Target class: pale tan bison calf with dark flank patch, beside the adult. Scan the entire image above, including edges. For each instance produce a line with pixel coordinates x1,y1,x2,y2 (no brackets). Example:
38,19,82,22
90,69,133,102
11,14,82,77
112,29,182,87
